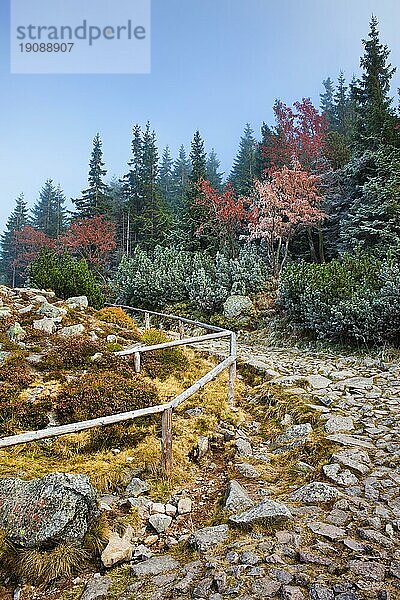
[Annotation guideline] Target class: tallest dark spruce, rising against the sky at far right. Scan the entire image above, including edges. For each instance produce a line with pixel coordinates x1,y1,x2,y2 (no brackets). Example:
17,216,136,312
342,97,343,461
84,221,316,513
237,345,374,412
351,16,399,151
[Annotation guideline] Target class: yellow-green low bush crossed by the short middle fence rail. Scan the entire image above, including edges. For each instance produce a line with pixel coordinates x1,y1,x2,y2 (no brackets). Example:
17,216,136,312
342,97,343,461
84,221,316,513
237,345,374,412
141,329,189,379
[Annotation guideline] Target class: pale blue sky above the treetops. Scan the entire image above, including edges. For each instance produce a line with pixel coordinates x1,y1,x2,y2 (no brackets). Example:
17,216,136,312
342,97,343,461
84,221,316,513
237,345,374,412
0,0,400,229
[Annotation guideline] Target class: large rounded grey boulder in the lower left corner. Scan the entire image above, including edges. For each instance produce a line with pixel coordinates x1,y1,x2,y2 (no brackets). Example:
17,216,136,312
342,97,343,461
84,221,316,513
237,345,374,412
0,473,99,548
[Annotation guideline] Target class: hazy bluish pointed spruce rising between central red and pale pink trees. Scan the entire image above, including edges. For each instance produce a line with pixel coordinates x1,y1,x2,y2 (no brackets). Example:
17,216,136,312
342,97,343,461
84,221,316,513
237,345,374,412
229,123,258,196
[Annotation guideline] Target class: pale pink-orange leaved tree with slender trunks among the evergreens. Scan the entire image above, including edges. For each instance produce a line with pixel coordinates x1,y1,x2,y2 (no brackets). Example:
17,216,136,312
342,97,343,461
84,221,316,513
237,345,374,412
249,163,324,275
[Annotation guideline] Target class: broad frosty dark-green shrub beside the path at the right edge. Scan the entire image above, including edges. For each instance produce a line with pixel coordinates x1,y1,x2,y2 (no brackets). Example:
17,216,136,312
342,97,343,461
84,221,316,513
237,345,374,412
278,255,400,343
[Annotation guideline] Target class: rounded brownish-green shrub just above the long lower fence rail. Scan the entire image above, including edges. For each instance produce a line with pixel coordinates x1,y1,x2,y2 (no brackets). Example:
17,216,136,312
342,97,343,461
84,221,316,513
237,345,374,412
55,368,159,423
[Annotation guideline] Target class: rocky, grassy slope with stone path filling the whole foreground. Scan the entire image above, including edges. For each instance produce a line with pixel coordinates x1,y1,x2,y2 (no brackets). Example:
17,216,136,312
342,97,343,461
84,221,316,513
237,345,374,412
0,287,400,600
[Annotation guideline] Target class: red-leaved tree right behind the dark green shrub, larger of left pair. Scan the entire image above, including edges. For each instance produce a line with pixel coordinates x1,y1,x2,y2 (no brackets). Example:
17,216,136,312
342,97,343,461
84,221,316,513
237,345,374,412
57,215,117,267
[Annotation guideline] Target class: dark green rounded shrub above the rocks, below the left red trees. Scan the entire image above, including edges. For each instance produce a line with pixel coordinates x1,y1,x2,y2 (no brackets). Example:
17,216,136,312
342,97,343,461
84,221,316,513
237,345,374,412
29,250,104,308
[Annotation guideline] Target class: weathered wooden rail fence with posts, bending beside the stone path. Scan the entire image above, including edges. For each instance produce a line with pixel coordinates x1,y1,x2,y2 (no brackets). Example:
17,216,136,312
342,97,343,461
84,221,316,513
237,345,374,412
0,304,236,476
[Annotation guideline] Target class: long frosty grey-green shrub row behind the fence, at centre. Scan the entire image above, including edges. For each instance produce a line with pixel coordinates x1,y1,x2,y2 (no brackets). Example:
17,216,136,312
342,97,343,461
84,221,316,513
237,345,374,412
114,246,268,313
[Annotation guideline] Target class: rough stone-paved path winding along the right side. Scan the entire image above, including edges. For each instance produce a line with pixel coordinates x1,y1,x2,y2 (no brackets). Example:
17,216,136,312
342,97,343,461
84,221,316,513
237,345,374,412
188,332,400,600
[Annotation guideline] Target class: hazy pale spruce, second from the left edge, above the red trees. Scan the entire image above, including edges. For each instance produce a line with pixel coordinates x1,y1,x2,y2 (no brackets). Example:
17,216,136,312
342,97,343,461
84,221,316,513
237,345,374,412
32,179,66,237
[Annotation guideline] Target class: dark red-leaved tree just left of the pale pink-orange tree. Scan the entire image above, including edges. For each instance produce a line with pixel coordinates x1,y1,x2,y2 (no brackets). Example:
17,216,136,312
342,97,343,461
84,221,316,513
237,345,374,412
196,180,252,257
